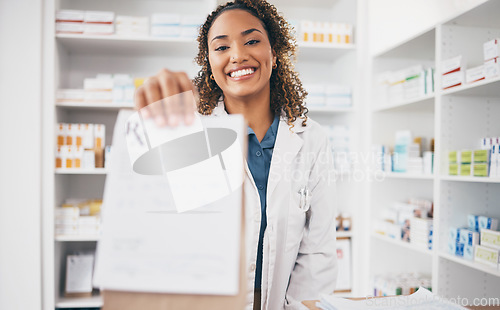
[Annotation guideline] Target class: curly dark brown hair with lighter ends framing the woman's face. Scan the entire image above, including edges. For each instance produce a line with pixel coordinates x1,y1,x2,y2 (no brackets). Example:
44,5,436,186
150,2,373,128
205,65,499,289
194,0,308,128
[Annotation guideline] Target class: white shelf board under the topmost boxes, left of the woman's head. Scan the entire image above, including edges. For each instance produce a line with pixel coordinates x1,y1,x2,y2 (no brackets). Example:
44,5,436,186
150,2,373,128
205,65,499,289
56,34,198,58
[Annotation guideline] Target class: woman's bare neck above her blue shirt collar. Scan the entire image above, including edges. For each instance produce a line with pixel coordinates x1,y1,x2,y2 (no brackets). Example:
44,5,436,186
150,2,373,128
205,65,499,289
224,92,274,142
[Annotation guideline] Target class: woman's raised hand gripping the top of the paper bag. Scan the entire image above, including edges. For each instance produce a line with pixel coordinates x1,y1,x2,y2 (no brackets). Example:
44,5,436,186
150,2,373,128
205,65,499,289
134,69,198,127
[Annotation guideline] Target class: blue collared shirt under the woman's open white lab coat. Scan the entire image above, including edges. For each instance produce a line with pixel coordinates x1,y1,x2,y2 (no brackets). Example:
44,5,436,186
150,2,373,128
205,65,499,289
247,115,279,288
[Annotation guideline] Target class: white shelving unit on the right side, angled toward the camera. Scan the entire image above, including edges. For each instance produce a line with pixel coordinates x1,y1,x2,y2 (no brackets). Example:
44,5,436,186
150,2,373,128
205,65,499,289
364,1,500,302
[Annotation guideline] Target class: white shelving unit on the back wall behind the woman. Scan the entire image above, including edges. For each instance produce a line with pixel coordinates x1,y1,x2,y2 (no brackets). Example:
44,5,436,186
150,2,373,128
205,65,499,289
42,0,362,310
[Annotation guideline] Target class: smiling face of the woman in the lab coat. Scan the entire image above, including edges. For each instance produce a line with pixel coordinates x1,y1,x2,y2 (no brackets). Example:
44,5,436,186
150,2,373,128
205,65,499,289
208,9,276,98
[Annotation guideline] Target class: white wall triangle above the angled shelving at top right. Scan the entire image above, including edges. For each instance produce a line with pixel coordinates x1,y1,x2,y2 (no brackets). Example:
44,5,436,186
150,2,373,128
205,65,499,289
368,0,485,55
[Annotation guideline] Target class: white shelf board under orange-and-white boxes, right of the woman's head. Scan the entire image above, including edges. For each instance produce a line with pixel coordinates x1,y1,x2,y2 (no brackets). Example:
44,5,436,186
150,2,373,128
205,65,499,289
297,41,356,61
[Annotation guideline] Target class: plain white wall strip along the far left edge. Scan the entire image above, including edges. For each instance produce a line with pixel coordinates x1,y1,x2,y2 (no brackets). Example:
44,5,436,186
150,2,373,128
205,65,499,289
0,0,42,310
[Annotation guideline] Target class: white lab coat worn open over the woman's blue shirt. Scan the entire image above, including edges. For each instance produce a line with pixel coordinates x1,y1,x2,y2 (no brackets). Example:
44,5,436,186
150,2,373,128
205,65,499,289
212,101,337,310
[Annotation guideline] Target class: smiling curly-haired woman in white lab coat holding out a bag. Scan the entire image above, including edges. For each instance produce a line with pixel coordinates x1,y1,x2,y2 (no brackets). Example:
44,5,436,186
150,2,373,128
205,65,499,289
136,0,337,310
